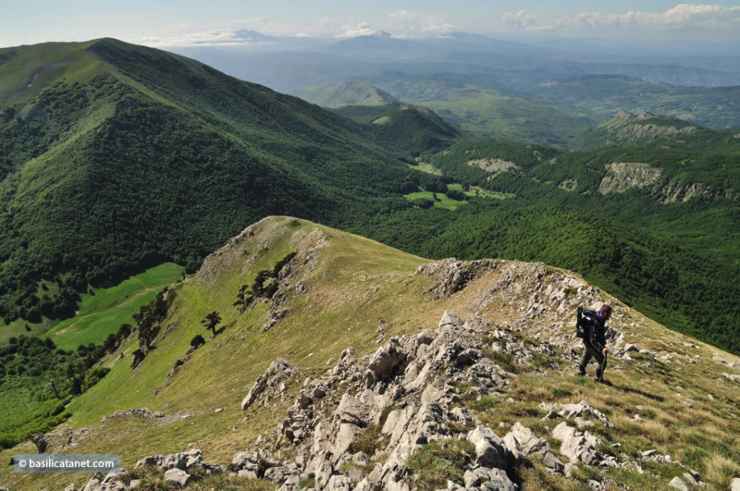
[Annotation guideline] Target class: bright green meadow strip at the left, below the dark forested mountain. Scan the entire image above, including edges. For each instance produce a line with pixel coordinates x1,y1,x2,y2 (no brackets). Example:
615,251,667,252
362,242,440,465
48,263,183,350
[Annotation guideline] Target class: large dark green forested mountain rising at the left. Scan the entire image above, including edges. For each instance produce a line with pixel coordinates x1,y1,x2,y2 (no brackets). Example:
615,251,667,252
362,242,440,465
0,39,405,321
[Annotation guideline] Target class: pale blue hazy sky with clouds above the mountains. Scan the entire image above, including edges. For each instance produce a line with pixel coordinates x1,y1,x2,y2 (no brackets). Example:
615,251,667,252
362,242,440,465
0,0,740,47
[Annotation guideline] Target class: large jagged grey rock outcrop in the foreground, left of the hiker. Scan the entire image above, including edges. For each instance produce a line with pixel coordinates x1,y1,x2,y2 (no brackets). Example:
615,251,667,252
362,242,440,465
232,312,524,490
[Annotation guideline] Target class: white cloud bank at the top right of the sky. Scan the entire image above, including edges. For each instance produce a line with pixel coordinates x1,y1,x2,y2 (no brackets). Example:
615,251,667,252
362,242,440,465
502,3,740,32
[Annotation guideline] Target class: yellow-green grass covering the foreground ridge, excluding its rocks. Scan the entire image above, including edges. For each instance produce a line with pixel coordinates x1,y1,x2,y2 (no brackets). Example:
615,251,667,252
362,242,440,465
0,218,740,489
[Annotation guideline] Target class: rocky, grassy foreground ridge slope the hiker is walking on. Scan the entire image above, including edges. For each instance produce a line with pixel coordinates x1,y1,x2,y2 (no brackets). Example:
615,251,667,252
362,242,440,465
0,217,740,490
